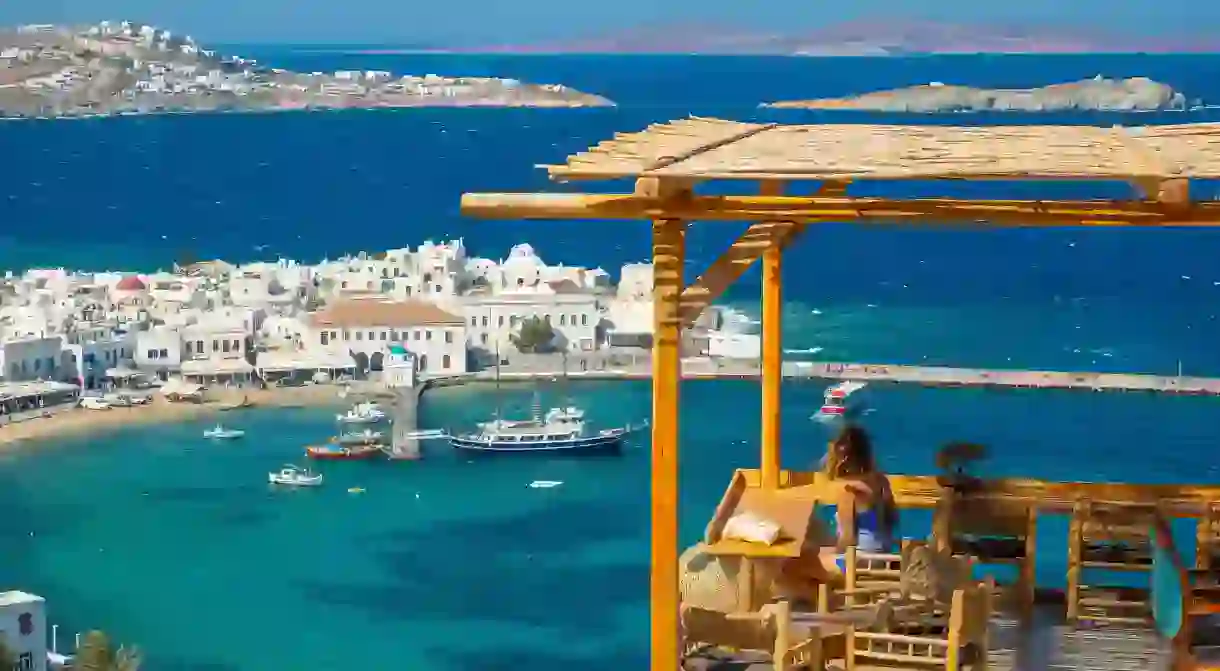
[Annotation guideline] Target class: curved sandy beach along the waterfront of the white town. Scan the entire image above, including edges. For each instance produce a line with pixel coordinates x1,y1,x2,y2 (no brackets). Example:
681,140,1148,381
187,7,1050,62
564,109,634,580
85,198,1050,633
0,384,380,449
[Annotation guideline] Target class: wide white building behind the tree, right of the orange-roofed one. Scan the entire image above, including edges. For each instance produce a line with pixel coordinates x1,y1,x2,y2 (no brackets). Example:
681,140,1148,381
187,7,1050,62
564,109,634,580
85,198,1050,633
462,279,601,357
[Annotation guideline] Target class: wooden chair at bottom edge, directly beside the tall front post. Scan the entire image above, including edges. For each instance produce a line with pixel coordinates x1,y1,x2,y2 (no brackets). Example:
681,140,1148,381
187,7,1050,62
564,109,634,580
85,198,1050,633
681,601,825,671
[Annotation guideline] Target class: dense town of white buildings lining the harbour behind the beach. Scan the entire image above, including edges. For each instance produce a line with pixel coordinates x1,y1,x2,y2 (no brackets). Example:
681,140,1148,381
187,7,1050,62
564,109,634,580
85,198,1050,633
0,240,759,405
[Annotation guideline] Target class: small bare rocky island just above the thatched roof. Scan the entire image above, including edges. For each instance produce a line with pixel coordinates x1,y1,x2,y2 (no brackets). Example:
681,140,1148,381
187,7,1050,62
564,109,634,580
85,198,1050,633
763,76,1186,112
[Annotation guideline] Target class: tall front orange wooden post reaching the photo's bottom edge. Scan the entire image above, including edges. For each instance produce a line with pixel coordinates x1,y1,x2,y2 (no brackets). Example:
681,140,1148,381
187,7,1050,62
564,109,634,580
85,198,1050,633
650,220,686,671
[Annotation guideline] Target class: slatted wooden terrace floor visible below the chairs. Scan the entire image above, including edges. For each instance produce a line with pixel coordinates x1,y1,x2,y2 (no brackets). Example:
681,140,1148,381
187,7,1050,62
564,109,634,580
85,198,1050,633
684,612,1169,671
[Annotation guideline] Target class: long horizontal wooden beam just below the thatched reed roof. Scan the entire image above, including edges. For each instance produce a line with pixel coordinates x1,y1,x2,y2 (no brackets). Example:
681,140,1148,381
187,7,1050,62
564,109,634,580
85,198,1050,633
461,193,1220,227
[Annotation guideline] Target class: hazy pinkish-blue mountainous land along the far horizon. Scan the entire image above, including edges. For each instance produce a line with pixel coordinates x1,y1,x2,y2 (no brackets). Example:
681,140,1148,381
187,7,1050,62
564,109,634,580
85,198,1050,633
465,20,1220,57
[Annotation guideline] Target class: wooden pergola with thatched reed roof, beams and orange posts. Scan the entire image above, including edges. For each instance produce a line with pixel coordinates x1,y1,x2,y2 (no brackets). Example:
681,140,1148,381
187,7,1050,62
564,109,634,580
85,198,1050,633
461,118,1220,671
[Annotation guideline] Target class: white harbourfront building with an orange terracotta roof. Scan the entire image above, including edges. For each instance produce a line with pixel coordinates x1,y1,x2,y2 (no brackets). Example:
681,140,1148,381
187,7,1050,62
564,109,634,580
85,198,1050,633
306,299,467,376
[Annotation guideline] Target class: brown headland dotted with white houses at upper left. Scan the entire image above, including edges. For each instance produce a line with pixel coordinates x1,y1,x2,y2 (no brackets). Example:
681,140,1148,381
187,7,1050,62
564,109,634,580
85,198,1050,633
0,21,614,117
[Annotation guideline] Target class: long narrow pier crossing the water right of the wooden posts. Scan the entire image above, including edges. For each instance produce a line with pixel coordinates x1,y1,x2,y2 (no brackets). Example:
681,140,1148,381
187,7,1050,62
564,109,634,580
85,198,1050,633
786,361,1220,397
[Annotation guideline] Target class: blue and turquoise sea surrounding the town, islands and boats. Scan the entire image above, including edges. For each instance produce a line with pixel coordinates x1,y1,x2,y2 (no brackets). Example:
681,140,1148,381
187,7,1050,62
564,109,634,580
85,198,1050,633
0,53,1220,671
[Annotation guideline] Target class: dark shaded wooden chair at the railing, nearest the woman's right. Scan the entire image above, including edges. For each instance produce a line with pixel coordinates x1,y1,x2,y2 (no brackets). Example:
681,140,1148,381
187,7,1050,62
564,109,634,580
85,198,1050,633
932,492,1038,620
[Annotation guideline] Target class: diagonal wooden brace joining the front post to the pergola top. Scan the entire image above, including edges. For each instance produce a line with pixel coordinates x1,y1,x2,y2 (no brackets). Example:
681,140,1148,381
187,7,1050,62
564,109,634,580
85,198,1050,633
682,182,847,328
